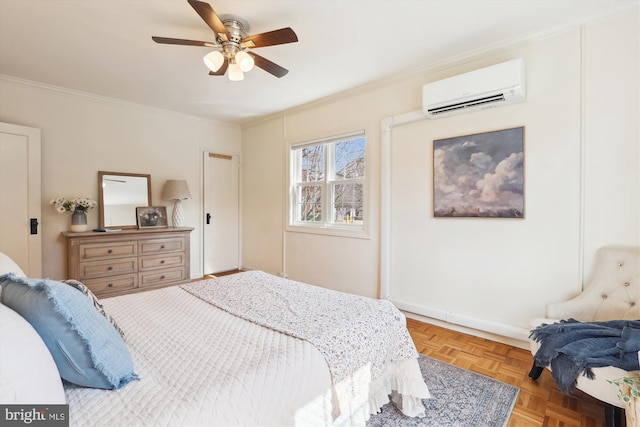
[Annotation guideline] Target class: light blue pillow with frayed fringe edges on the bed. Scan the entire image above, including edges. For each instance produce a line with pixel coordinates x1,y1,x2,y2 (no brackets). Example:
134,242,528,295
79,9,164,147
0,273,138,389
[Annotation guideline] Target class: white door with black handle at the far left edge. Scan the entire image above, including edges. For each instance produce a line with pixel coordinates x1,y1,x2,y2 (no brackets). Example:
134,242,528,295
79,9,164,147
0,123,42,277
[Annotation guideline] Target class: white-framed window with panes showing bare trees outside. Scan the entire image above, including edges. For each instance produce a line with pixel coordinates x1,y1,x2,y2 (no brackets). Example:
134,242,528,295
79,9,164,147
290,131,366,234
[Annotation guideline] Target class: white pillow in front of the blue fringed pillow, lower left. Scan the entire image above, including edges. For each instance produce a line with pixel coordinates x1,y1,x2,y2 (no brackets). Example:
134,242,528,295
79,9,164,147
0,304,66,405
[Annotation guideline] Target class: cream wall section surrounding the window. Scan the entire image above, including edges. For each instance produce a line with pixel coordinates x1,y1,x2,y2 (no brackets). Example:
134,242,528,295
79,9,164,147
284,110,380,297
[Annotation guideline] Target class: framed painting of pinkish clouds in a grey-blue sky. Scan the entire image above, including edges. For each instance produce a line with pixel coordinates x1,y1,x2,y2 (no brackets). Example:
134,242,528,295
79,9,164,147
433,127,524,218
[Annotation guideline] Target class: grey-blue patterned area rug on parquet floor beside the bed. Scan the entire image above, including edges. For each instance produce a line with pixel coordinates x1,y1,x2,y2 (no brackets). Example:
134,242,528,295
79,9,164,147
367,355,520,427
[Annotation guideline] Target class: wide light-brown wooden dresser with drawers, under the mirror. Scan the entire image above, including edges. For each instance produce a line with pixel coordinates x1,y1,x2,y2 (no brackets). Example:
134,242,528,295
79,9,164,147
62,227,193,297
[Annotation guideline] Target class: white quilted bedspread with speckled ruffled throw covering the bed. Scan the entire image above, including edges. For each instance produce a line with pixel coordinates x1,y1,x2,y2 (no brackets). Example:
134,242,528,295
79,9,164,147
0,256,429,426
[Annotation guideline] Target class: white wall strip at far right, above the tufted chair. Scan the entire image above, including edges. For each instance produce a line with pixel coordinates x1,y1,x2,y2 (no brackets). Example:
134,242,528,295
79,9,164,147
584,9,640,264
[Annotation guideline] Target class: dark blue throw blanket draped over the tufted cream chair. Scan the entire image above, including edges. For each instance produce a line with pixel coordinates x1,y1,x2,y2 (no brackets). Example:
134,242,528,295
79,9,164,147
529,319,640,393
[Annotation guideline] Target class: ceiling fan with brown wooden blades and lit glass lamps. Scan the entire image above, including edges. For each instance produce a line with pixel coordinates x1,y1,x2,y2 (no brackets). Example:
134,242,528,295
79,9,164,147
151,0,298,81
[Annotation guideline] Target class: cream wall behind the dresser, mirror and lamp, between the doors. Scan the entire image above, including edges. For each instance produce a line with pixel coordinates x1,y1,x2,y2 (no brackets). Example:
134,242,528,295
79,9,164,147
0,78,241,279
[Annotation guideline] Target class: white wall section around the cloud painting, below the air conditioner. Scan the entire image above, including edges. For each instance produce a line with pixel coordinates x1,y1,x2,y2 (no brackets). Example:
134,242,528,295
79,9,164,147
390,31,581,339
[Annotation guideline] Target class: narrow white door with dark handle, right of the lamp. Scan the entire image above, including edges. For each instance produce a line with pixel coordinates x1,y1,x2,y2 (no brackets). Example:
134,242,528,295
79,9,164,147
202,153,240,274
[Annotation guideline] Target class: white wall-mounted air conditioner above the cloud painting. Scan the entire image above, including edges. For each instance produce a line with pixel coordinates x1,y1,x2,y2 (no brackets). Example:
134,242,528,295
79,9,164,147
422,59,525,119
